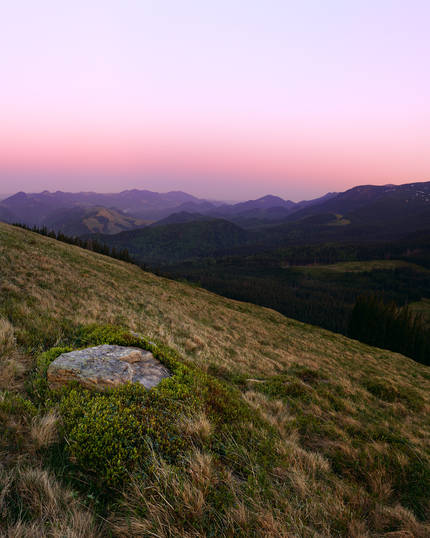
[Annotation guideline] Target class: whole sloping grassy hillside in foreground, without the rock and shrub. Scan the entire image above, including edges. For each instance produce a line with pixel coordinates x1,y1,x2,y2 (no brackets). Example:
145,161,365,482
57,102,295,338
0,223,430,538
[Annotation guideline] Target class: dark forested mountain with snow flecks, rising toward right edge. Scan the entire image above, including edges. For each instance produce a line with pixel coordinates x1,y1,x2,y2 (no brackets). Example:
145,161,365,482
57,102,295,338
83,183,430,265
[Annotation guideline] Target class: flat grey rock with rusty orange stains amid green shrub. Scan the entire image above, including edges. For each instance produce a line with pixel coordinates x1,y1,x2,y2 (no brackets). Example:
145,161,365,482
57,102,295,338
48,345,171,390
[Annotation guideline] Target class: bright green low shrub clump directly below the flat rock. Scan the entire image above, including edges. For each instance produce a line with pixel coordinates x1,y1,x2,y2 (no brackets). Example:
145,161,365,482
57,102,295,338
60,378,195,486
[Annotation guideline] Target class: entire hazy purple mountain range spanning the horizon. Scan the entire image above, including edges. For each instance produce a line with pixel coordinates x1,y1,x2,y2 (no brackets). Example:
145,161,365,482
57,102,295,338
0,182,430,245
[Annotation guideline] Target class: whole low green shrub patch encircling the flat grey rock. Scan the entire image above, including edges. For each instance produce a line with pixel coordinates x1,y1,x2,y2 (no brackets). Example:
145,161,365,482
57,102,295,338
33,325,275,488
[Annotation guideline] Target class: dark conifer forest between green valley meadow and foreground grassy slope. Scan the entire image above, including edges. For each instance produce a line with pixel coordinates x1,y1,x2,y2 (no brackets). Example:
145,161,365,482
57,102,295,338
165,256,430,362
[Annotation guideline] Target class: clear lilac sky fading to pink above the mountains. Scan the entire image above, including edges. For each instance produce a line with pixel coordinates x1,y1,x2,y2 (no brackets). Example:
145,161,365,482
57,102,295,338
0,0,430,200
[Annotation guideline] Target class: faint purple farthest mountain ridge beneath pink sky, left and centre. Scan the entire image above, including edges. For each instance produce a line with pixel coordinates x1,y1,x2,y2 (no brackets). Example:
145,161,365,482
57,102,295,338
0,189,338,229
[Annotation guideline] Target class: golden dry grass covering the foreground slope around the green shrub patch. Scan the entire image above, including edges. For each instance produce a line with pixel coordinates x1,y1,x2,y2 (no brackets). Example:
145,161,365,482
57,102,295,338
0,223,430,538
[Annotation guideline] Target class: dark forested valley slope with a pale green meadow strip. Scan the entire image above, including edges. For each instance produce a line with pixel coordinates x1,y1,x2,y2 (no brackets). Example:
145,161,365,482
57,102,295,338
163,243,430,336
